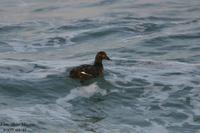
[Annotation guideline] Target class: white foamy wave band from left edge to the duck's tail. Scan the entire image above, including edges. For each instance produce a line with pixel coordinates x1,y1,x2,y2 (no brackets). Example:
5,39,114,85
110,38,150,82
0,59,88,80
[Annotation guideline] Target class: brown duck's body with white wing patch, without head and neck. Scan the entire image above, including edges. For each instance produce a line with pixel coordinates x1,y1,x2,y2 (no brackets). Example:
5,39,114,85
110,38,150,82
70,65,103,80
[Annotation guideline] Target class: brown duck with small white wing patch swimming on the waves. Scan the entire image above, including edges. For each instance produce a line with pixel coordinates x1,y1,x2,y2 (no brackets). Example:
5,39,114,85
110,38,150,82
69,51,111,82
